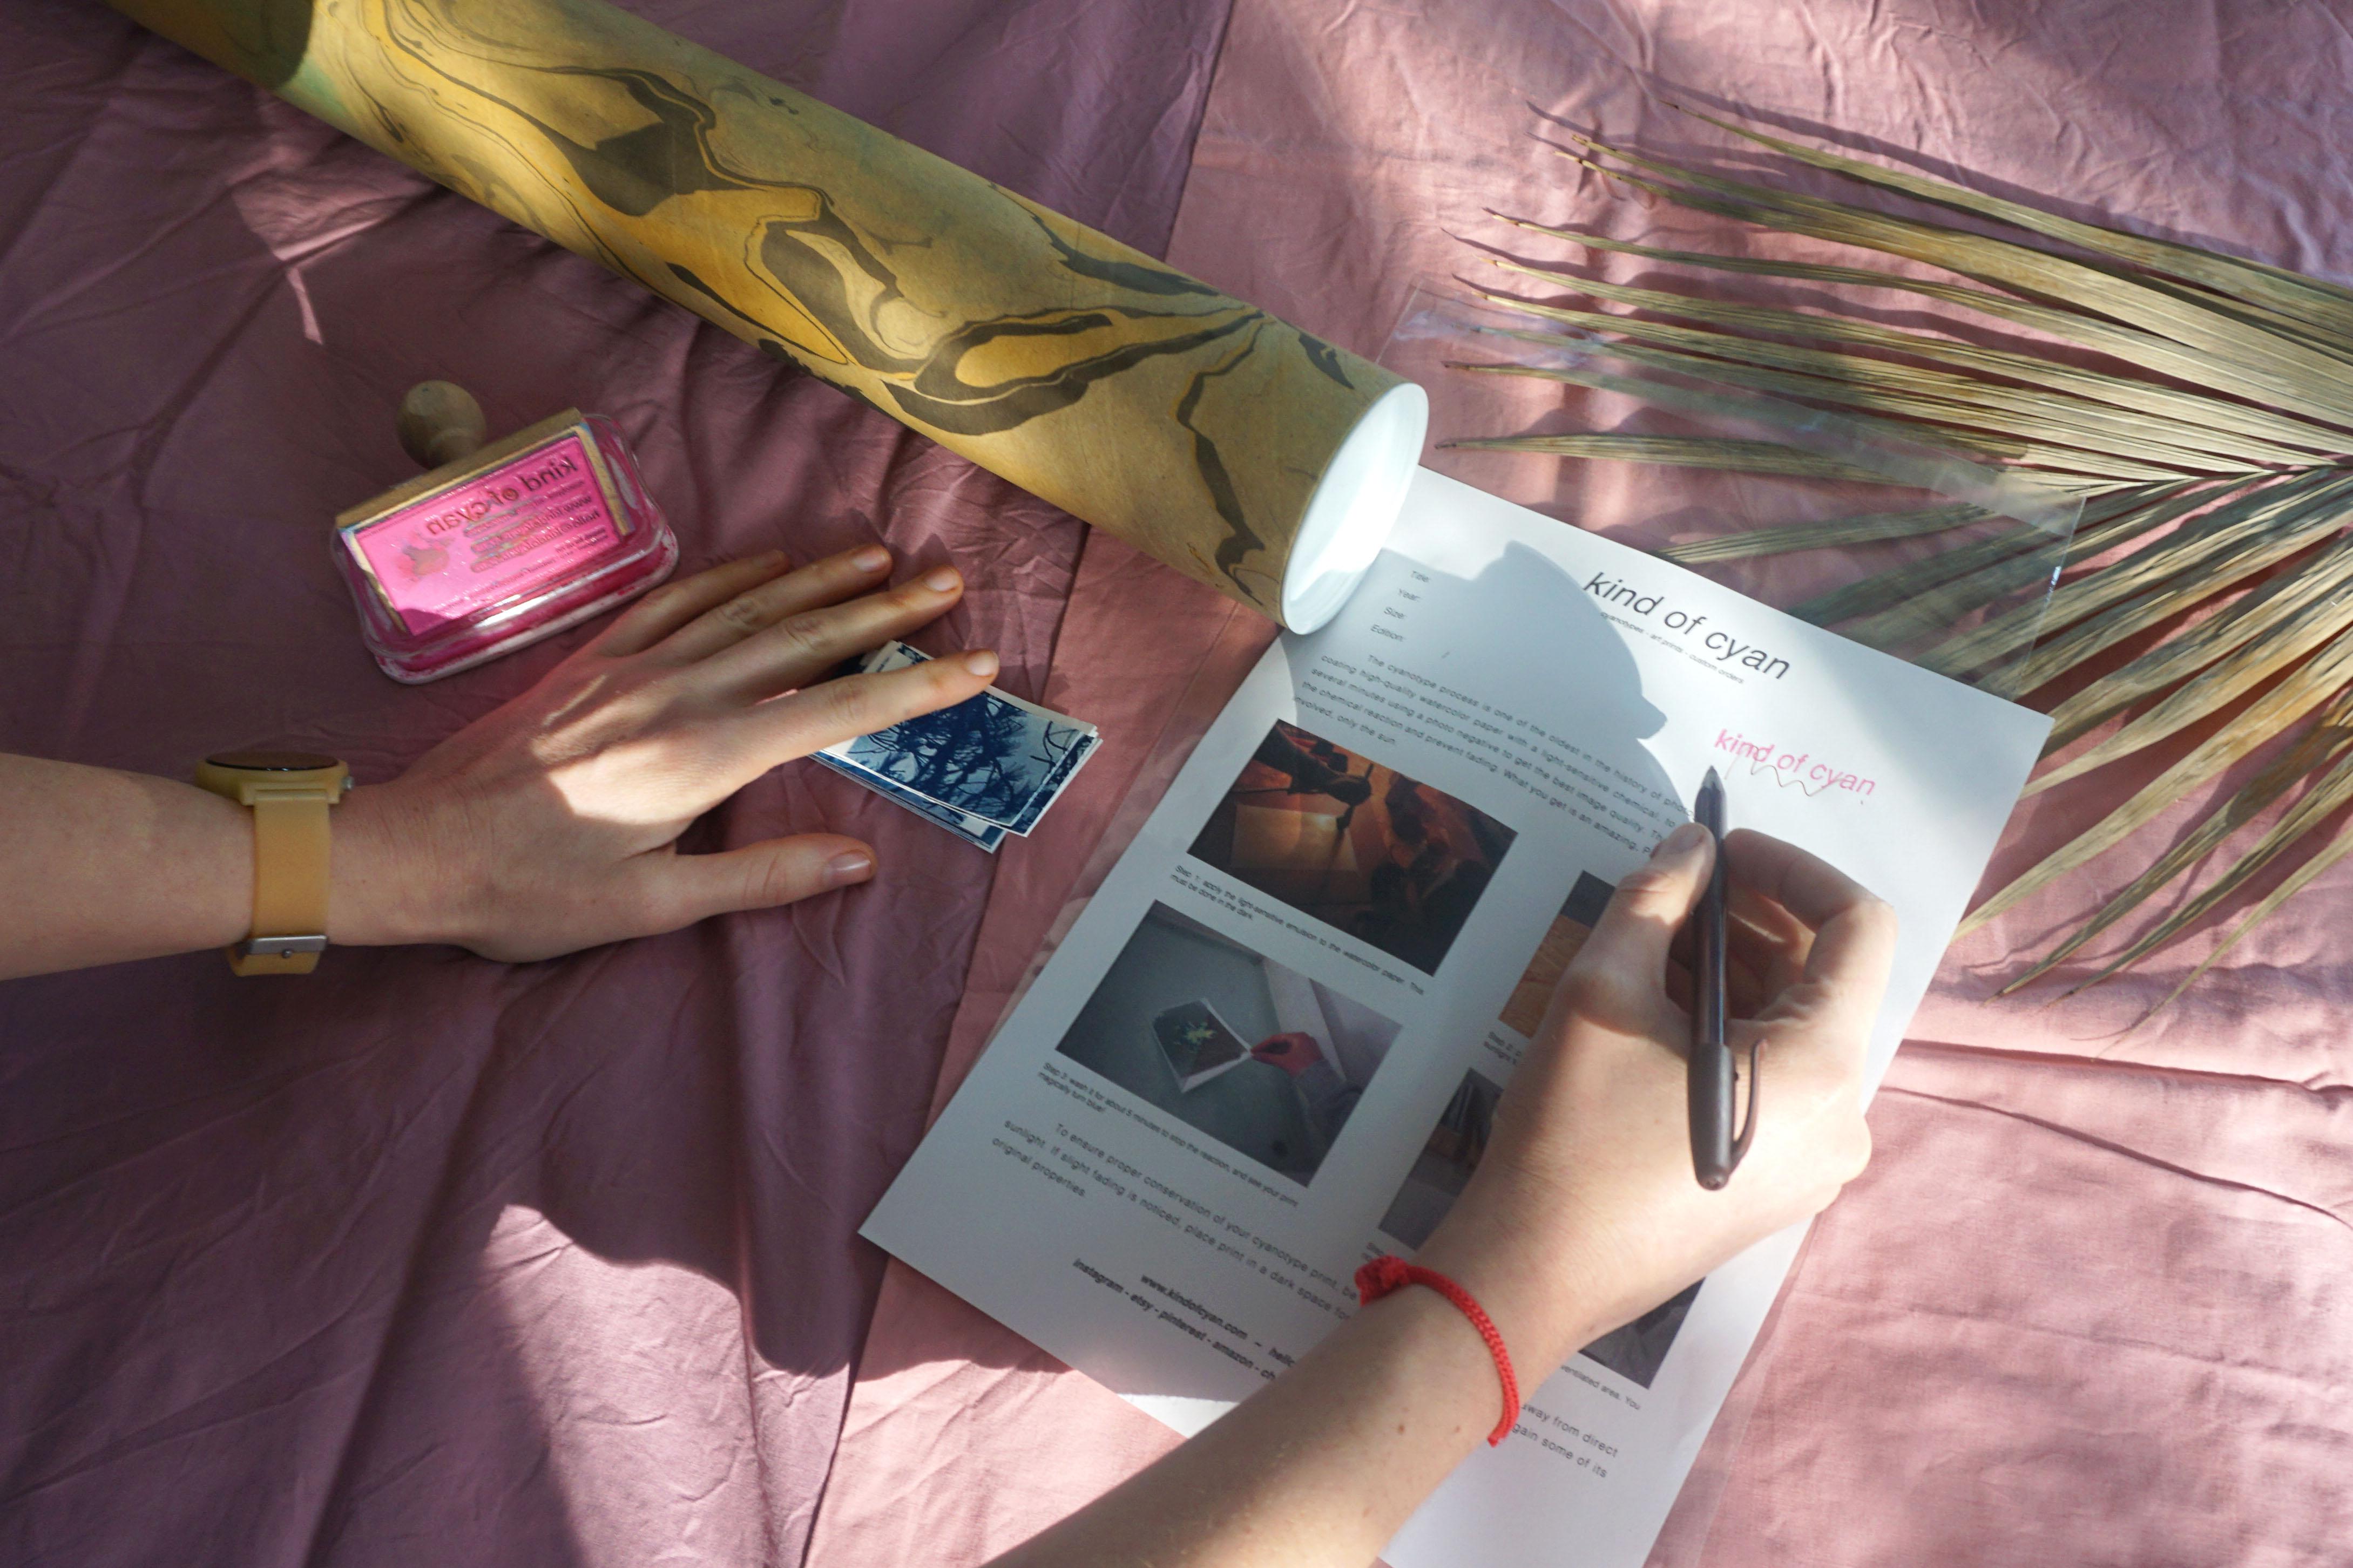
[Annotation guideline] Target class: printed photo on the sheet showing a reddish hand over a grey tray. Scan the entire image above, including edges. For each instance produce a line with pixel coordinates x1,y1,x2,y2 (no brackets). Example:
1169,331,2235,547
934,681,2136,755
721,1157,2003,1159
1054,902,1398,1185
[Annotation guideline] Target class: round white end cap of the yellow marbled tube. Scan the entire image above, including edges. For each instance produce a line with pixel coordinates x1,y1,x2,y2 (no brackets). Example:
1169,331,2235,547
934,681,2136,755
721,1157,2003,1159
1282,381,1431,633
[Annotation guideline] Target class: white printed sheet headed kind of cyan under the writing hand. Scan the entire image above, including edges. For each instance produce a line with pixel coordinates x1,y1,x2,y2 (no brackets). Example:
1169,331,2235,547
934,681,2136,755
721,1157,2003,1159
863,470,2047,1568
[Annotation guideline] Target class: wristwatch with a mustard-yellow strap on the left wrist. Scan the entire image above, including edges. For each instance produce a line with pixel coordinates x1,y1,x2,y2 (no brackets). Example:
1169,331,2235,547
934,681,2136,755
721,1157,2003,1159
195,752,350,975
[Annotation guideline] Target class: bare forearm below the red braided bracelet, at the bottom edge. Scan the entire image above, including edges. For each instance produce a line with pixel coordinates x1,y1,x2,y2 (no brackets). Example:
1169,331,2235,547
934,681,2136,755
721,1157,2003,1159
1000,1288,1501,1568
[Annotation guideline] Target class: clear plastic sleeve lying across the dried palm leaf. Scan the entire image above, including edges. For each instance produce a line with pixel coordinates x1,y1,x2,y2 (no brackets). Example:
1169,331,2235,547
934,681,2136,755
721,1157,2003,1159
1381,289,2097,689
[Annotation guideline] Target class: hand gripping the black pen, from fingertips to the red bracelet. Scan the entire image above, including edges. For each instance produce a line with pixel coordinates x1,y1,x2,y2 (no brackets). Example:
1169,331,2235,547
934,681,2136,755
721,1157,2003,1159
1419,823,1897,1387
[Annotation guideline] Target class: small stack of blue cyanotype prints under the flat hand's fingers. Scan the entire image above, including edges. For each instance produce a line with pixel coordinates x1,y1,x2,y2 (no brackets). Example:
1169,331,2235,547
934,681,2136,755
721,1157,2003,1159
814,642,1101,853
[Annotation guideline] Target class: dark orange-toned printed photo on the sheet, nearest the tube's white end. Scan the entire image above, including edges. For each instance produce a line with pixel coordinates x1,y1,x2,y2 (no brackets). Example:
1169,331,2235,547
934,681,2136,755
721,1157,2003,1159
1193,722,1516,975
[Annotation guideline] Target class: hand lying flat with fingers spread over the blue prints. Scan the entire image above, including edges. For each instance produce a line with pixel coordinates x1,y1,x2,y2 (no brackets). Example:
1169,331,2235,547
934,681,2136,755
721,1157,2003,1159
327,545,998,959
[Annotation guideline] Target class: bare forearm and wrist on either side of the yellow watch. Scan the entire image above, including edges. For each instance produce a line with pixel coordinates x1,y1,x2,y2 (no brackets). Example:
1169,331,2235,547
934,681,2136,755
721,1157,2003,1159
0,755,418,978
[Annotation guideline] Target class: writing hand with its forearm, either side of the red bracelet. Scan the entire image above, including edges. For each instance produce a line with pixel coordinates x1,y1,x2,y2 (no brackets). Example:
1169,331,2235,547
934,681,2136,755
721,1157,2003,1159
998,823,1897,1568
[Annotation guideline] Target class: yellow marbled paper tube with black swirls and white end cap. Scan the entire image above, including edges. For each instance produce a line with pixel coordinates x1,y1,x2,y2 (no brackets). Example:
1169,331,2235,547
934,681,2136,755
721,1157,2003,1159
116,0,1428,630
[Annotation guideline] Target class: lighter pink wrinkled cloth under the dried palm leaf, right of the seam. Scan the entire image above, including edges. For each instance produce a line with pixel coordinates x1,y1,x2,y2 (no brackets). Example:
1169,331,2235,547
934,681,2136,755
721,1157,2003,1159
812,0,2353,1568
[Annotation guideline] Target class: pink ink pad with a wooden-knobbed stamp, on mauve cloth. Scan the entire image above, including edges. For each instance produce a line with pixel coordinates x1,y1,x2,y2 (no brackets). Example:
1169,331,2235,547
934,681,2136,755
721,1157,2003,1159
334,381,678,684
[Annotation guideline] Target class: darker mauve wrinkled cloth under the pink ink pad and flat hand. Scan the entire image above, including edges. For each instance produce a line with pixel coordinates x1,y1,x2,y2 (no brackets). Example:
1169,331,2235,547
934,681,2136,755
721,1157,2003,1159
0,0,1223,1568
